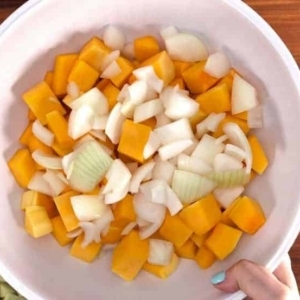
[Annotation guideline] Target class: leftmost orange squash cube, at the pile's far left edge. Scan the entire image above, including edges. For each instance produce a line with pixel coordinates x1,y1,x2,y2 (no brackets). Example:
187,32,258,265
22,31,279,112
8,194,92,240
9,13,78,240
8,149,36,188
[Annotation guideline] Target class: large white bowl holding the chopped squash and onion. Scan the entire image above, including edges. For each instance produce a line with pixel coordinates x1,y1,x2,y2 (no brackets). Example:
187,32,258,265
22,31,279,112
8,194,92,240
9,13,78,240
0,0,300,300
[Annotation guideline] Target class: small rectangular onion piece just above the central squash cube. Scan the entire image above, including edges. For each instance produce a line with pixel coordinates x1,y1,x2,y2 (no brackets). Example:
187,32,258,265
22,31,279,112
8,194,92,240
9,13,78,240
133,99,164,123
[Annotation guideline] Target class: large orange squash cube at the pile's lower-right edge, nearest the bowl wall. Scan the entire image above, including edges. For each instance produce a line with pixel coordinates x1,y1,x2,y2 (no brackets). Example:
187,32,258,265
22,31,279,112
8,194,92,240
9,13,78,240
228,196,266,234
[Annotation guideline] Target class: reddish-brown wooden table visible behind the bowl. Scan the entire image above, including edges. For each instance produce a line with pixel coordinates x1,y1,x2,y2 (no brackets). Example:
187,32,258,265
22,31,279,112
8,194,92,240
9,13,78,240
0,0,300,287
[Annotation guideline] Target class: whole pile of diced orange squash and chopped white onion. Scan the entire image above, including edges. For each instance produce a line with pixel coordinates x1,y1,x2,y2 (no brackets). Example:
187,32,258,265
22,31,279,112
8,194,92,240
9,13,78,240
8,26,268,281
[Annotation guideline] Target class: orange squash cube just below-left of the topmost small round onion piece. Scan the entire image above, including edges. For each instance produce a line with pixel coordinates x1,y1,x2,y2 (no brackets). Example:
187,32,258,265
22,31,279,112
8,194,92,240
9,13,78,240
79,37,111,72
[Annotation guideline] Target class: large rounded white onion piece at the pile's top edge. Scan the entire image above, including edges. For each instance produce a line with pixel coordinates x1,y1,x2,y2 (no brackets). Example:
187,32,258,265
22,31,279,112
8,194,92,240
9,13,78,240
165,33,208,62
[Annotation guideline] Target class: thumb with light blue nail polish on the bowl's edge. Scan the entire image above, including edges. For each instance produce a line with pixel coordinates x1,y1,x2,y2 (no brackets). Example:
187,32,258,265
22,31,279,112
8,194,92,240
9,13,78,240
212,260,290,300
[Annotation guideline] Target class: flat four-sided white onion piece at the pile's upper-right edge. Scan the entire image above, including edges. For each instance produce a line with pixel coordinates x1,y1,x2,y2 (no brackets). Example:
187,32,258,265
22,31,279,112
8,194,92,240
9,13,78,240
231,74,258,115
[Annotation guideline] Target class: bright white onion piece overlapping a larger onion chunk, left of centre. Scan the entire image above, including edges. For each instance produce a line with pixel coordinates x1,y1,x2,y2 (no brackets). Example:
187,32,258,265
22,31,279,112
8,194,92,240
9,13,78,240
68,105,95,140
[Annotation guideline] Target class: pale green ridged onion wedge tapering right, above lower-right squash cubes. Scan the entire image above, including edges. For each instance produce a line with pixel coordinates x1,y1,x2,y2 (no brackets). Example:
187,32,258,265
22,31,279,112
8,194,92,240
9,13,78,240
172,170,217,204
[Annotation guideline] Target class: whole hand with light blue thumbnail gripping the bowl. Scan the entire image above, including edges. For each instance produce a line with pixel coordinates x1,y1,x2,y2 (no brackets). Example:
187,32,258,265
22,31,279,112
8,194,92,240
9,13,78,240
212,255,300,300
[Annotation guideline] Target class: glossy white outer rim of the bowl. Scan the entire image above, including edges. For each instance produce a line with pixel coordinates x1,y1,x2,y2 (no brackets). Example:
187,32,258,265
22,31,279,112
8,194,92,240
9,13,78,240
0,0,300,300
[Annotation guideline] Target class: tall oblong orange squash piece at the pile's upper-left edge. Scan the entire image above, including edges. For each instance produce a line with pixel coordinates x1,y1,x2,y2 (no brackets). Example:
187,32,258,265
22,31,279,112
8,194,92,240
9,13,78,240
52,54,78,96
